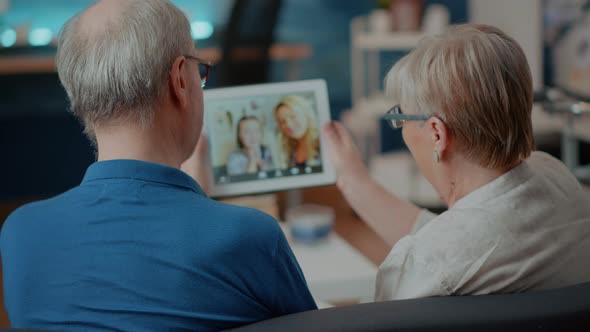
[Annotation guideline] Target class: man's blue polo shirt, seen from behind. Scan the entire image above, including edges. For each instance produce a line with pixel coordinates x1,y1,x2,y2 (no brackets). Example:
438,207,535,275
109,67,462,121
0,160,317,331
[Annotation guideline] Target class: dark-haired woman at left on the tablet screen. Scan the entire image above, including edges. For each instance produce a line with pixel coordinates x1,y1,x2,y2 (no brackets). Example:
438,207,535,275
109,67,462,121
227,116,274,175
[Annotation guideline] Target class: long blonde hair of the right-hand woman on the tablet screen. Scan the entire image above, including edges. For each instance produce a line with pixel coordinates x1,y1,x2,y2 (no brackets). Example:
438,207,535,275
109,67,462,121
274,95,319,168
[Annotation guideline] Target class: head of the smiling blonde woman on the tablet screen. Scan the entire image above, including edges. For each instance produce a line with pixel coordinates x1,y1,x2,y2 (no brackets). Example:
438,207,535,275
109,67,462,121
275,96,313,140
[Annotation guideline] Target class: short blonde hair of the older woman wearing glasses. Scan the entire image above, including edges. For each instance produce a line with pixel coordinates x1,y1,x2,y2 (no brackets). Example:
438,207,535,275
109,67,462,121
386,24,534,168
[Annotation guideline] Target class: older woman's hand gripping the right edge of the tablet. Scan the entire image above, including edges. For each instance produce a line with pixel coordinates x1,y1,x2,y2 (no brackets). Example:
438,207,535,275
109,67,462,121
322,121,369,189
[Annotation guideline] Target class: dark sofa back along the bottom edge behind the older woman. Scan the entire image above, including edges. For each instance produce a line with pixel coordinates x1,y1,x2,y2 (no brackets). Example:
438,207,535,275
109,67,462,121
227,283,590,332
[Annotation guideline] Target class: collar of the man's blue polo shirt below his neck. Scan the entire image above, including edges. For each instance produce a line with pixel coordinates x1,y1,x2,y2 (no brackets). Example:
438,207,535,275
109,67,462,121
82,159,207,196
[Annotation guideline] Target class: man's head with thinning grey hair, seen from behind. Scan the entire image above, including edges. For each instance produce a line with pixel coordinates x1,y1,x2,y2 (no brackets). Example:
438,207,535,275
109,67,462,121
56,0,203,157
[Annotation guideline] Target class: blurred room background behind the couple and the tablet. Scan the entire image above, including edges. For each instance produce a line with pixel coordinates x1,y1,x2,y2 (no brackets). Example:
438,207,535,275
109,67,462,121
0,0,590,326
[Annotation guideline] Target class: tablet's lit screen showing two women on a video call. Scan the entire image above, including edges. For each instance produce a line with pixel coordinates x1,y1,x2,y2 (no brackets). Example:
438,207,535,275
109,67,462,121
205,92,322,184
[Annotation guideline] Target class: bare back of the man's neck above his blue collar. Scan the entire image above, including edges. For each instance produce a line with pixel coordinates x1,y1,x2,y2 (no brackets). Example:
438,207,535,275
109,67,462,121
96,122,183,168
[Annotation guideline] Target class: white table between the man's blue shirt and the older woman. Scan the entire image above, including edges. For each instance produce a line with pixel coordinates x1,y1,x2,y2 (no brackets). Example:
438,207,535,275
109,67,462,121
281,223,377,306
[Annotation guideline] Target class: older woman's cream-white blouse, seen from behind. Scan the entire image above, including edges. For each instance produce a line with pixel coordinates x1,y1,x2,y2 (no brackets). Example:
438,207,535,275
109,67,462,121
375,152,590,301
